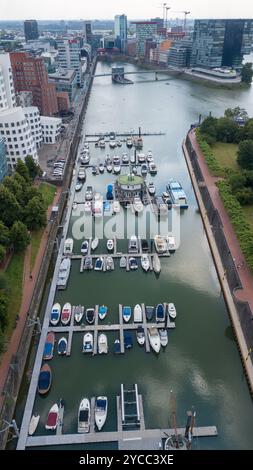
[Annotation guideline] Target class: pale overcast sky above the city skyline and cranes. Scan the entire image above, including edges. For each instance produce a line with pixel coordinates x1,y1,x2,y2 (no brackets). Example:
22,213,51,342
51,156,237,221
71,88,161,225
0,0,253,20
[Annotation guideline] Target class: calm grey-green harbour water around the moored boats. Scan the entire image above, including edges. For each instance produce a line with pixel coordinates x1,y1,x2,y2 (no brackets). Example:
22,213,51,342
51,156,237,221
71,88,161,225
14,58,253,449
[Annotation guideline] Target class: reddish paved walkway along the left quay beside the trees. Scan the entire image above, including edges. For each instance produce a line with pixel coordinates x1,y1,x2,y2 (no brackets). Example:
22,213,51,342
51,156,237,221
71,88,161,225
0,187,61,409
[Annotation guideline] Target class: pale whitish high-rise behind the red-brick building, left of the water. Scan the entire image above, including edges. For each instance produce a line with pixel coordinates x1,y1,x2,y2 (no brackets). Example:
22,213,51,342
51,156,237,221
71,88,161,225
57,38,83,87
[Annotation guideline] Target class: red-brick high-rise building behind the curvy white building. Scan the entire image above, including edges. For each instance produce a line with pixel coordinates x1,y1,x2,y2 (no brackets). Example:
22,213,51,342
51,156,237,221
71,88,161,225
10,52,58,116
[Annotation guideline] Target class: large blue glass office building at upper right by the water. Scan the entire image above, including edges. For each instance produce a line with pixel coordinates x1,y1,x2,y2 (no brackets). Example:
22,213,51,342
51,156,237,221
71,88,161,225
191,19,253,69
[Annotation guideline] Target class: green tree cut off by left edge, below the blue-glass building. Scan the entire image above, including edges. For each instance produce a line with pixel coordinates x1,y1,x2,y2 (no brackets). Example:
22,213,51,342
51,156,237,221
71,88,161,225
0,184,21,227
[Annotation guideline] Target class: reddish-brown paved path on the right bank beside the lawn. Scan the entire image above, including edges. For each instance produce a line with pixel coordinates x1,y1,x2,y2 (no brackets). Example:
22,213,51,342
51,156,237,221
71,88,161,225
189,130,253,311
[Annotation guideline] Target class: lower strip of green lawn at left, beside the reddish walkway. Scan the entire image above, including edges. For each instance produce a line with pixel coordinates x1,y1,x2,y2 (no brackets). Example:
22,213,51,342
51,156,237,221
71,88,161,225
6,253,25,336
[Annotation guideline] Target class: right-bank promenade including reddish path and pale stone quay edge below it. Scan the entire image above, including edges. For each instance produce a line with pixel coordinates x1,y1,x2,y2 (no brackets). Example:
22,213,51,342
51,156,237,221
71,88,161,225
183,130,253,395
